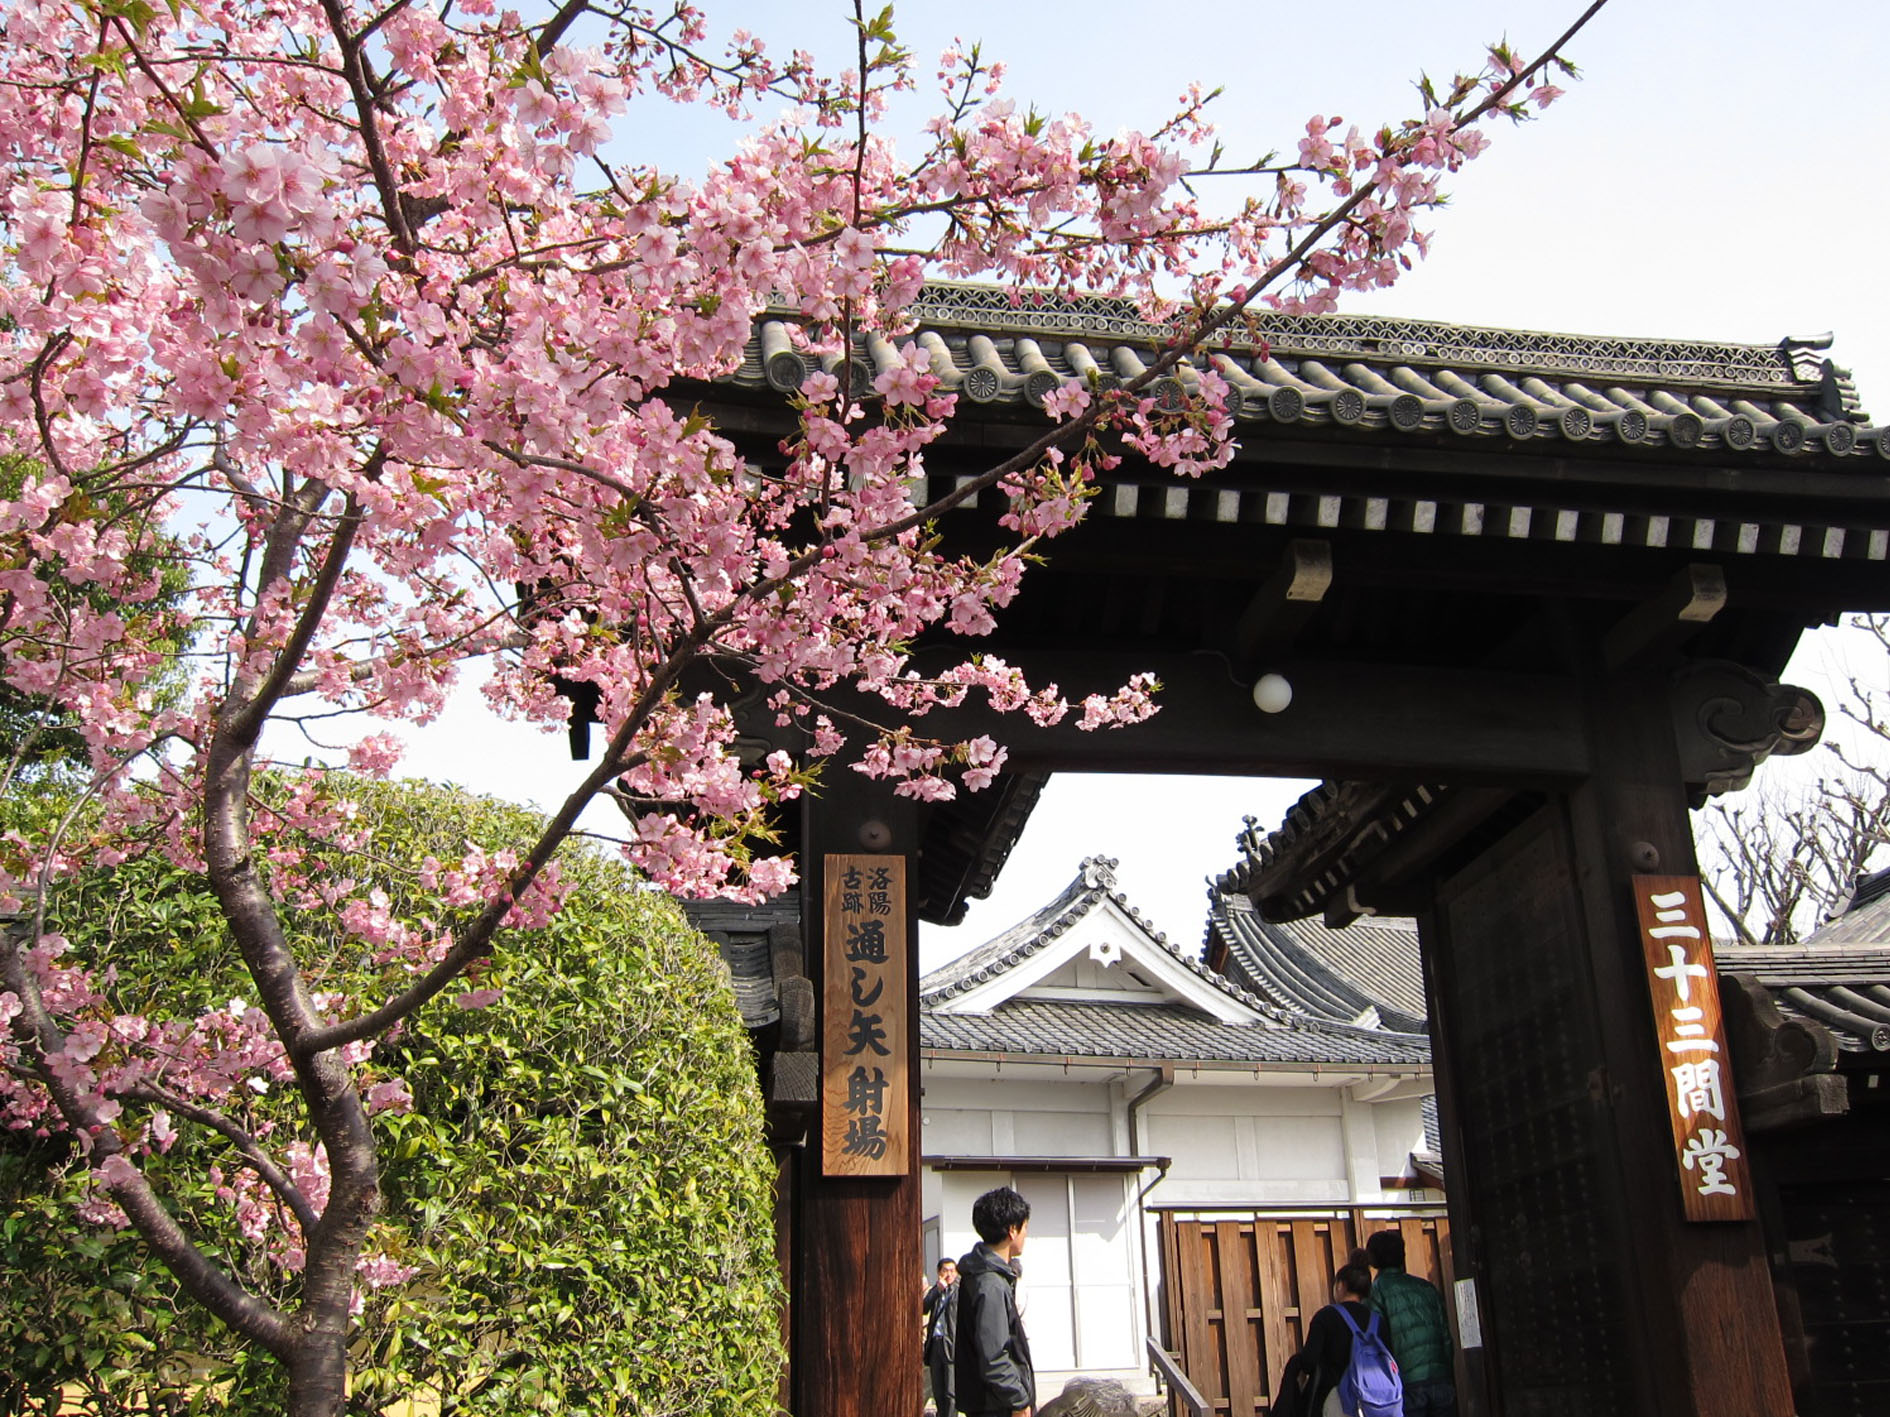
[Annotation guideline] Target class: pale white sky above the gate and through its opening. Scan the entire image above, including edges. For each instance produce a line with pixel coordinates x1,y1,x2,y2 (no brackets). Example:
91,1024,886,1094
355,0,1890,967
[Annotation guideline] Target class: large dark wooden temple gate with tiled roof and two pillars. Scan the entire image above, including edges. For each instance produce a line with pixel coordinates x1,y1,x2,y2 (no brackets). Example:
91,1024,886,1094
669,287,1890,1417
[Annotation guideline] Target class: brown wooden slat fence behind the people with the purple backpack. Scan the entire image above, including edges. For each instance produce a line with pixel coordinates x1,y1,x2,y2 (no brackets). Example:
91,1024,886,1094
1160,1209,1455,1417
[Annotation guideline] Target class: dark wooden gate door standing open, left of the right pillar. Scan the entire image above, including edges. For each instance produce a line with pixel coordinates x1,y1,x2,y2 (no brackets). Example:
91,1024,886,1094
1427,807,1635,1417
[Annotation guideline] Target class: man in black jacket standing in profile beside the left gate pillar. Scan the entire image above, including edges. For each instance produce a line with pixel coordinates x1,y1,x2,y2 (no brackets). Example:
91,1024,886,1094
956,1187,1038,1417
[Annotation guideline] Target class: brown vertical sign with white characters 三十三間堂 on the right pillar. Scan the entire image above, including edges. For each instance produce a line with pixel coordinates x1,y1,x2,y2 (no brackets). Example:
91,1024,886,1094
1633,877,1754,1221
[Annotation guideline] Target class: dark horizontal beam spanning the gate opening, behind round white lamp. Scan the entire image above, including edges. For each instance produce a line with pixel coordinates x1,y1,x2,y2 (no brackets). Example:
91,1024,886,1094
876,650,1589,786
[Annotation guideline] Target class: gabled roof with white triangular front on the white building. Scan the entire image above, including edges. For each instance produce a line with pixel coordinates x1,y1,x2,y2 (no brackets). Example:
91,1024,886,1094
919,856,1431,1066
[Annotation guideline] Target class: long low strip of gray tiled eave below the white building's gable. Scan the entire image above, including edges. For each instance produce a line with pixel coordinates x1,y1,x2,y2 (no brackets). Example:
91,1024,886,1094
919,999,1431,1066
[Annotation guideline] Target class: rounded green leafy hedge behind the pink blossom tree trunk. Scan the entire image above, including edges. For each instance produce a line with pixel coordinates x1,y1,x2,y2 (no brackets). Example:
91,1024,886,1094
0,780,781,1417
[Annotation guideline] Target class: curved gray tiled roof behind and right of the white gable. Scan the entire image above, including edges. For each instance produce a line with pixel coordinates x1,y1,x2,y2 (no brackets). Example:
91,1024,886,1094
1208,888,1425,1033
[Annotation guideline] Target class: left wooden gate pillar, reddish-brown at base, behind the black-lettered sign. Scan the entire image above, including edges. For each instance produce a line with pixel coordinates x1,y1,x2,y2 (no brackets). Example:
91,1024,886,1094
788,771,924,1417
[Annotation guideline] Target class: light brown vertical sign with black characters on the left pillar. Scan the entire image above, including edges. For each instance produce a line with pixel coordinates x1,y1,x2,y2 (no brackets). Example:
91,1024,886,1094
820,856,911,1175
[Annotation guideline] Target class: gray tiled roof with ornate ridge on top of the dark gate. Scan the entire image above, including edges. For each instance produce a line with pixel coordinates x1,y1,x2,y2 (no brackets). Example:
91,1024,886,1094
731,283,1890,459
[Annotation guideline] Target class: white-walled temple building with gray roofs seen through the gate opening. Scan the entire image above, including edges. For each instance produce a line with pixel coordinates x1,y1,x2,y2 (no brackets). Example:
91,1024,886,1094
919,856,1444,1396
